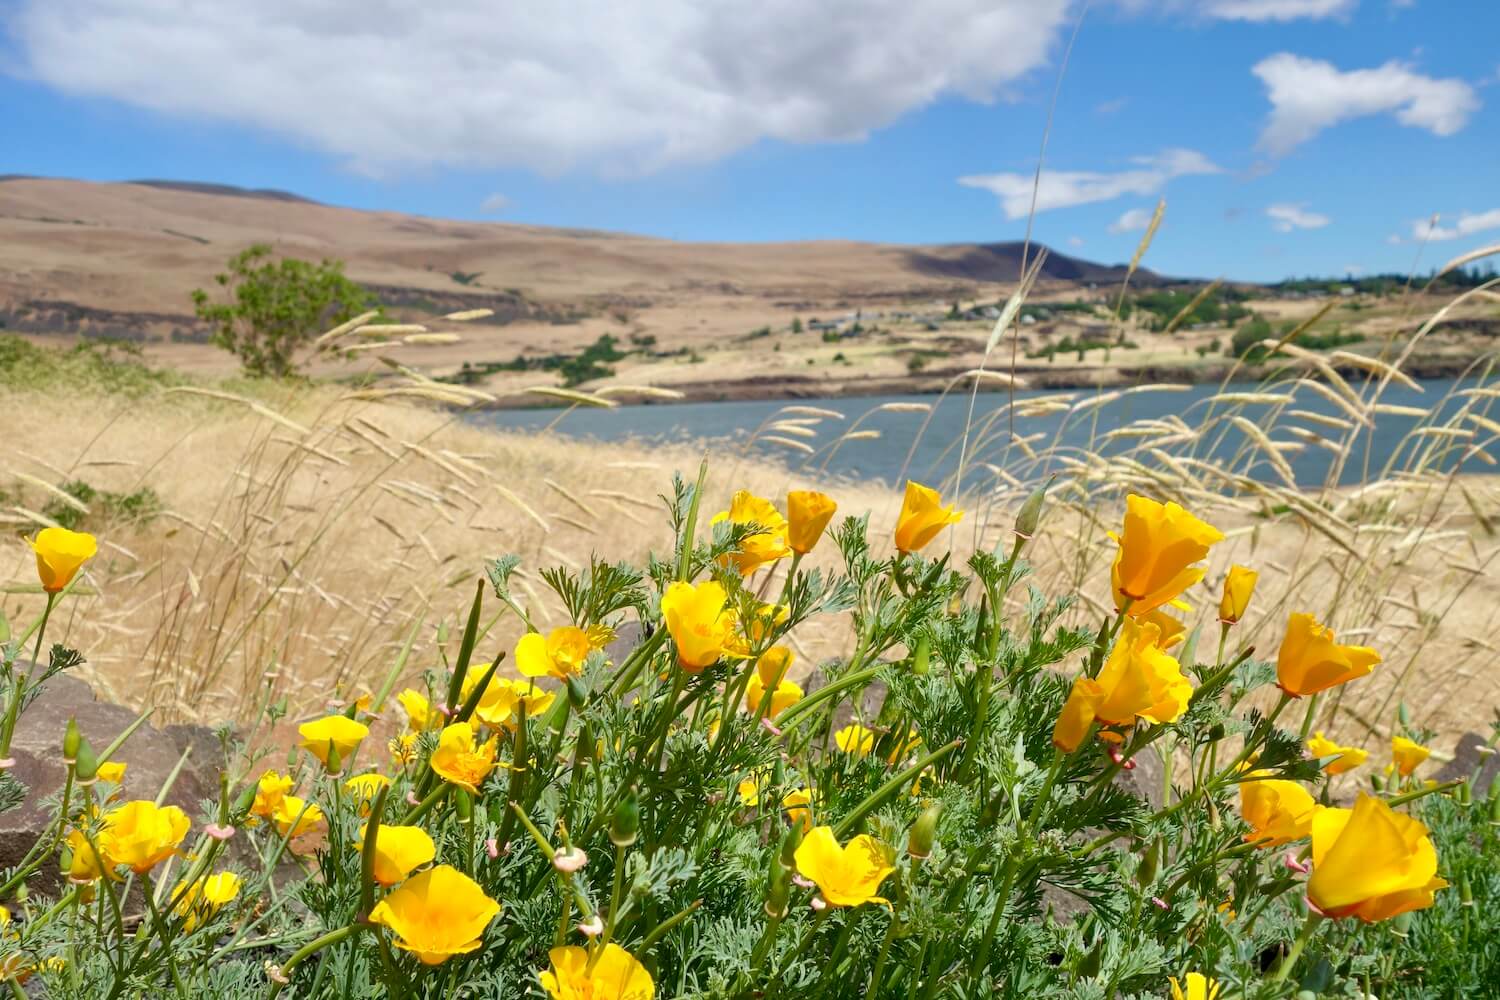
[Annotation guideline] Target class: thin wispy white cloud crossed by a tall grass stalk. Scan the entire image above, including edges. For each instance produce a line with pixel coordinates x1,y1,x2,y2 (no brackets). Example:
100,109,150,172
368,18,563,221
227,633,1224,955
959,150,1224,219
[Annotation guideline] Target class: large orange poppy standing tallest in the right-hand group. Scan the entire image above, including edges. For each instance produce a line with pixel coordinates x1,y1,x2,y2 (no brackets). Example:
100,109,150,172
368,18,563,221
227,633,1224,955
1110,493,1224,615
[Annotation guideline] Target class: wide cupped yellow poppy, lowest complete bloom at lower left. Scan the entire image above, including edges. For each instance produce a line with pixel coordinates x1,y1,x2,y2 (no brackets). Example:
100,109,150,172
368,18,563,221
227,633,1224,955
369,863,500,966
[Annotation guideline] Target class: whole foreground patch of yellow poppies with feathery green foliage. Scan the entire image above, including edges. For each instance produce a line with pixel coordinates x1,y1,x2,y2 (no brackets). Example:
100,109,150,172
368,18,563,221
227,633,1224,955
0,472,1500,1000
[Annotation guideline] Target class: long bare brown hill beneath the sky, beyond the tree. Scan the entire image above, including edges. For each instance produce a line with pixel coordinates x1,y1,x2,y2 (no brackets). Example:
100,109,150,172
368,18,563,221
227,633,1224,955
0,177,1154,344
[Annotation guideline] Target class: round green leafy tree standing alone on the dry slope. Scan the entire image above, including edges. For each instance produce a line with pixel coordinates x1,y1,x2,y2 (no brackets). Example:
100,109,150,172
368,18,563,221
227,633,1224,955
192,243,377,378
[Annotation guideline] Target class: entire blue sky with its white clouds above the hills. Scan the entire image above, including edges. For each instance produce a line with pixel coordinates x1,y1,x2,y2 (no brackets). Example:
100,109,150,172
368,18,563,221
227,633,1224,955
0,0,1500,280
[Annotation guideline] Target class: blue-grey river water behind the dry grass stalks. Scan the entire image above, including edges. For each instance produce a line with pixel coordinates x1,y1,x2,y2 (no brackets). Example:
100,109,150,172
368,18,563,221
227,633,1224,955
476,379,1500,486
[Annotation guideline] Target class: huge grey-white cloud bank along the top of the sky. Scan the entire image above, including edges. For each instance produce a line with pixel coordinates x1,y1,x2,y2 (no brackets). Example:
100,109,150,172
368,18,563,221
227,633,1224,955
6,0,1073,172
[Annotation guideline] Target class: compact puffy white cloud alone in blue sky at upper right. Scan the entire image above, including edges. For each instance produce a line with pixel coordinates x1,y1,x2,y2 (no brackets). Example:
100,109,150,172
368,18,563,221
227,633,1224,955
1251,52,1479,156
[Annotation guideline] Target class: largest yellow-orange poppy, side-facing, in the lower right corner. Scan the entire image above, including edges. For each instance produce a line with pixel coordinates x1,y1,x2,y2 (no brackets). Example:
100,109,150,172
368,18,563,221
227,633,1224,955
1308,795,1448,924
